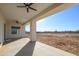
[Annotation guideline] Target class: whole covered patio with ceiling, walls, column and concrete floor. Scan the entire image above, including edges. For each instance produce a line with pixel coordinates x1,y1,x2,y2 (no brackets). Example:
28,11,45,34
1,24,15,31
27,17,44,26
0,3,76,56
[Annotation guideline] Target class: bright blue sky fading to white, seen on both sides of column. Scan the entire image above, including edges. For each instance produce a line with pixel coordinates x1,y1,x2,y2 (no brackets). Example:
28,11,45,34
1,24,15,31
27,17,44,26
25,5,79,32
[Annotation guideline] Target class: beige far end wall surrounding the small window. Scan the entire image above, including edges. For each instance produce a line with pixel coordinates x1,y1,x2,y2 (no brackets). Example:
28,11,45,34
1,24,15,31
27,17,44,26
6,21,26,39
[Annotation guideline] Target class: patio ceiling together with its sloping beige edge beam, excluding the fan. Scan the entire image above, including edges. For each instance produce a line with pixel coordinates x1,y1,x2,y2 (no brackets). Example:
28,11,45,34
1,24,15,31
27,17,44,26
0,3,76,24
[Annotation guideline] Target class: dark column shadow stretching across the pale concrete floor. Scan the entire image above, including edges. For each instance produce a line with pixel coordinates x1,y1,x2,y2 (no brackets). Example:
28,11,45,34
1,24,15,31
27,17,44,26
15,41,36,56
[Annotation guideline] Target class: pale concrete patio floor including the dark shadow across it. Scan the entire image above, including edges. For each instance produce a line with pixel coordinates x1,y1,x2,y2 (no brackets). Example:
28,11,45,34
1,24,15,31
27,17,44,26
0,38,76,56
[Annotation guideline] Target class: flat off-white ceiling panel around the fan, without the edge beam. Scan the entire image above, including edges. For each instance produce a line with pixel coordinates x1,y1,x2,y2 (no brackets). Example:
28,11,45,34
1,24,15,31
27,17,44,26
0,3,52,23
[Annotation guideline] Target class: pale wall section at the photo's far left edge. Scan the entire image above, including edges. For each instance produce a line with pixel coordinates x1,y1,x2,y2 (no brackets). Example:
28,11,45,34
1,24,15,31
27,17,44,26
0,13,5,43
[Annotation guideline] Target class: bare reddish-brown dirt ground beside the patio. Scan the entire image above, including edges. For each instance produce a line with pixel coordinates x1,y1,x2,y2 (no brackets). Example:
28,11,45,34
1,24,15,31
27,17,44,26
37,33,79,55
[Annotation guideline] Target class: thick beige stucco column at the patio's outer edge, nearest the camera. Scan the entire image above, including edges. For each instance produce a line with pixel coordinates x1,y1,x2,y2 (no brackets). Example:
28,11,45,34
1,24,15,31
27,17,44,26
30,20,36,41
